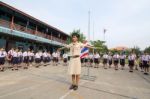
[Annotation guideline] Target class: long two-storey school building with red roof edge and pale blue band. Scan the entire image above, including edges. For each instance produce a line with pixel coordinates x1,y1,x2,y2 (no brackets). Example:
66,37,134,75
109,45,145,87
0,1,70,51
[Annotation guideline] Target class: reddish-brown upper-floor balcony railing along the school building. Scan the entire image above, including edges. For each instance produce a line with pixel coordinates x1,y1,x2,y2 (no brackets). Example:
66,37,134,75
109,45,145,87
0,19,66,44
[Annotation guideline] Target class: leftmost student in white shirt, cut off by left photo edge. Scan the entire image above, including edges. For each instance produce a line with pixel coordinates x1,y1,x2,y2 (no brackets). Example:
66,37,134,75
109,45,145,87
0,48,7,71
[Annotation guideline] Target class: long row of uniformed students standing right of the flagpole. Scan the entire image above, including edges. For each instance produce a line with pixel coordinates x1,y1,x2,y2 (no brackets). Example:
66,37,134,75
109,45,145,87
81,52,150,75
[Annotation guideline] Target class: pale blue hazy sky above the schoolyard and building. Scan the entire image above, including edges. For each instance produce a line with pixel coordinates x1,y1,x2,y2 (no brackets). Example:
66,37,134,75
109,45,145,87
0,0,150,50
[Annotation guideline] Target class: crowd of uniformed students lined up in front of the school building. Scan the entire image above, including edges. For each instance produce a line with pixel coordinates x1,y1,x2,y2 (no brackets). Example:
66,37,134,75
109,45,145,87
0,48,52,71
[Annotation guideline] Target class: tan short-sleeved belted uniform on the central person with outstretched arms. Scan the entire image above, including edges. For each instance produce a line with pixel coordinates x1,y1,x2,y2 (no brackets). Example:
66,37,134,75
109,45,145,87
66,42,85,75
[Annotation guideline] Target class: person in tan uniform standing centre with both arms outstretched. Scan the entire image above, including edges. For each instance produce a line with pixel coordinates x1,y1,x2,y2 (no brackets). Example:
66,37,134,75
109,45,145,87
59,33,94,90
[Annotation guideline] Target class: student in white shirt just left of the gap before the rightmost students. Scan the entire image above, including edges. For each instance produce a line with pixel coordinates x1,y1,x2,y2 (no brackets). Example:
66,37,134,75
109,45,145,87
128,52,136,72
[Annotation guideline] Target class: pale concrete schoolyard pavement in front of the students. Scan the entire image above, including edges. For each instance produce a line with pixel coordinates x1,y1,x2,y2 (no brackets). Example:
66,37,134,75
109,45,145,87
0,65,150,99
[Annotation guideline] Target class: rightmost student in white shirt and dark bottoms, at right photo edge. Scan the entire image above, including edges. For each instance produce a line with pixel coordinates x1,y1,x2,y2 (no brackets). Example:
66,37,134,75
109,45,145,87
143,52,150,75
